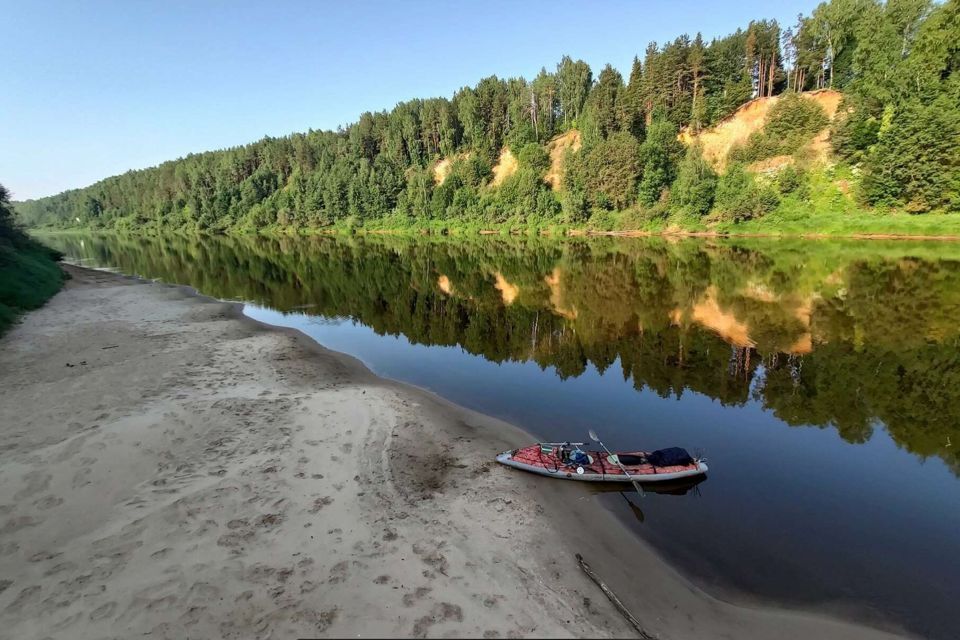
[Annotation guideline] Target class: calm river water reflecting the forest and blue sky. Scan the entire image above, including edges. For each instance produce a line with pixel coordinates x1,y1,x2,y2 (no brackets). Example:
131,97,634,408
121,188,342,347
44,235,960,638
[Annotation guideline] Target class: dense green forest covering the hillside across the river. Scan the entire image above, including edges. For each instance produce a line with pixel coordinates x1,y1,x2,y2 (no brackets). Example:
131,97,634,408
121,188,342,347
16,0,960,232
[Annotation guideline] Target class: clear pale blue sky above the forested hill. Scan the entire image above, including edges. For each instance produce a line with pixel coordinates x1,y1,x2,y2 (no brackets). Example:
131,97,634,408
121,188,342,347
0,0,816,200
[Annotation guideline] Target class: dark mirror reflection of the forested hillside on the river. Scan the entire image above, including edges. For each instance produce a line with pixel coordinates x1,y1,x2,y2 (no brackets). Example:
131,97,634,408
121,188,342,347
47,232,960,471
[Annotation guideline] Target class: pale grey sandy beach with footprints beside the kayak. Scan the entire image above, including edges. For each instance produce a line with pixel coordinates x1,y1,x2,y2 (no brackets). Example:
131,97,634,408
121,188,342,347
0,267,908,639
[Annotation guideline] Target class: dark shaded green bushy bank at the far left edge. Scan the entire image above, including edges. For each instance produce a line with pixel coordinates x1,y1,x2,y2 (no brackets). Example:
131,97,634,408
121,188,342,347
0,184,63,334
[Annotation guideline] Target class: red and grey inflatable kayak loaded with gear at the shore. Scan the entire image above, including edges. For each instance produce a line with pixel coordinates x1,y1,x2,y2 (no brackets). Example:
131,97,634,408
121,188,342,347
497,442,707,483
